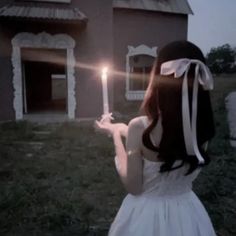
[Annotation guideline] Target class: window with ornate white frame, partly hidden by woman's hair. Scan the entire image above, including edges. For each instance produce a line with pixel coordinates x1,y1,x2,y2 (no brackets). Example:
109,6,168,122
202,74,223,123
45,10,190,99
126,45,157,100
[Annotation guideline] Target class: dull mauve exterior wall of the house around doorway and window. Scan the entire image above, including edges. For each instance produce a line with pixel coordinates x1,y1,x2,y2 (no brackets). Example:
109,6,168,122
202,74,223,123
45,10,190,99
0,0,187,120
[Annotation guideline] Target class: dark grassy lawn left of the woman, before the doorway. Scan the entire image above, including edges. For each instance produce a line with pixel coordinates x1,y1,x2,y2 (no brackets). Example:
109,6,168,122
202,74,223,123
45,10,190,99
0,122,123,235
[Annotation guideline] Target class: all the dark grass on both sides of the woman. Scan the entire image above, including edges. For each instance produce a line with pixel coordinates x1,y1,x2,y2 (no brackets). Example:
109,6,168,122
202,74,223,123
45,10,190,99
0,75,236,236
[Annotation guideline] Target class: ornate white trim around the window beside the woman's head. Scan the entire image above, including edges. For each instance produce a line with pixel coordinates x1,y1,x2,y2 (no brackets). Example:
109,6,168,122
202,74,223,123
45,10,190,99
125,44,157,101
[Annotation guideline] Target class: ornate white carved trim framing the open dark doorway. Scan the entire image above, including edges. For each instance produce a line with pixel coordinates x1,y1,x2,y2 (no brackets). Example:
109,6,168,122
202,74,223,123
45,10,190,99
11,32,76,120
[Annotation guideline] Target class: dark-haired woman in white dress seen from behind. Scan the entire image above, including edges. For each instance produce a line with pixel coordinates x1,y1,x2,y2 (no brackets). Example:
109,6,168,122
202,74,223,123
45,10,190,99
96,41,215,236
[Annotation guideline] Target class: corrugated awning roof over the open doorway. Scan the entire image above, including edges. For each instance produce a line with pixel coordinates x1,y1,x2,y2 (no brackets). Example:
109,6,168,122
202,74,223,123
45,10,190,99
0,4,87,22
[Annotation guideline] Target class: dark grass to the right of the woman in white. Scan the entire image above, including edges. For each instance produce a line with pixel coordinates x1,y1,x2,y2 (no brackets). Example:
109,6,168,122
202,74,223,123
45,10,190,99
194,75,236,236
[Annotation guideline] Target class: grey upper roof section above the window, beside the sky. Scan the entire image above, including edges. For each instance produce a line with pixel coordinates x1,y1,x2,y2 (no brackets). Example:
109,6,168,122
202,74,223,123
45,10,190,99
113,0,193,14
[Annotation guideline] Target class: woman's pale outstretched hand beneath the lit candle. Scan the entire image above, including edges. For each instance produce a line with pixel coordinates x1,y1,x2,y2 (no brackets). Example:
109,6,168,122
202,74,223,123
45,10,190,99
94,121,128,137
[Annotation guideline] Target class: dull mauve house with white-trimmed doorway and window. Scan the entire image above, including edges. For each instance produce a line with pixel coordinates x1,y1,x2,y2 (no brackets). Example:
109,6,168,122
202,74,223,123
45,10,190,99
0,0,192,121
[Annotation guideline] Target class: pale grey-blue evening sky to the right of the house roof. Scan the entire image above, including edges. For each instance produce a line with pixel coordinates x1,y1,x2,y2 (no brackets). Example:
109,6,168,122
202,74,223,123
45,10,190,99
188,0,236,54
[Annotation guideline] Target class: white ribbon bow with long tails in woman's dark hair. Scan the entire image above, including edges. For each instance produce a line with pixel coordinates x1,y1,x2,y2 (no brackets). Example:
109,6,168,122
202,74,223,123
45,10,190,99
160,58,213,163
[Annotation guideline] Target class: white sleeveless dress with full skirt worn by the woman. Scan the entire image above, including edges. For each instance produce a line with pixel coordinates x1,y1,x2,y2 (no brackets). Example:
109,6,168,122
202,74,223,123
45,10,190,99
109,117,216,236
